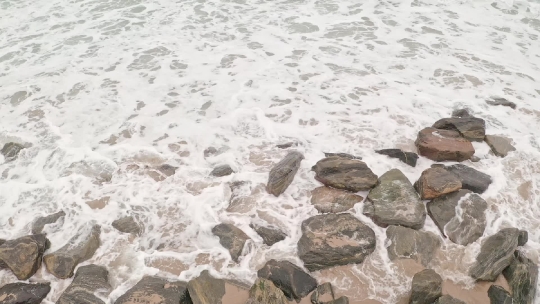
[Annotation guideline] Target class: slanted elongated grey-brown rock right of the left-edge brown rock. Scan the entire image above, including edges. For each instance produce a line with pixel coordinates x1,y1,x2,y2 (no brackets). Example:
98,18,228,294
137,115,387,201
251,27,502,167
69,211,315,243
43,225,101,279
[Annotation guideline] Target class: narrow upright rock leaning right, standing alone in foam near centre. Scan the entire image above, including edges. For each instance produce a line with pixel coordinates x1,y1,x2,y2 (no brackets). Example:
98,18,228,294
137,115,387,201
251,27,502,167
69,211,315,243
266,151,304,196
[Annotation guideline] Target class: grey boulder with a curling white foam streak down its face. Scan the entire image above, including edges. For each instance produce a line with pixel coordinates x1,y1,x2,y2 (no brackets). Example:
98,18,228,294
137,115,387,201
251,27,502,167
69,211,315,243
427,190,488,246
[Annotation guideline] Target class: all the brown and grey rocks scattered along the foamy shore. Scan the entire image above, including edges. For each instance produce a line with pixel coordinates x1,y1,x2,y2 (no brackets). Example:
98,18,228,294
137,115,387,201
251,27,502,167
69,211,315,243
0,109,538,304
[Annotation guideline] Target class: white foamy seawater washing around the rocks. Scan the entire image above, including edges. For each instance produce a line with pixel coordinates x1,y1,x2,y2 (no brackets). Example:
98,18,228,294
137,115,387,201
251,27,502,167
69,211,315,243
0,0,540,303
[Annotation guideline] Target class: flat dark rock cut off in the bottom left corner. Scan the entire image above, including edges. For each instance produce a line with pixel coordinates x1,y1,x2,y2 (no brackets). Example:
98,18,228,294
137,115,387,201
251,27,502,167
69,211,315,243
0,283,51,304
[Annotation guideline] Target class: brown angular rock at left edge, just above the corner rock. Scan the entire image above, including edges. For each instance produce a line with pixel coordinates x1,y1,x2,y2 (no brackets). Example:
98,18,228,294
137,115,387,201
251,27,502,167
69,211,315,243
0,234,51,280
